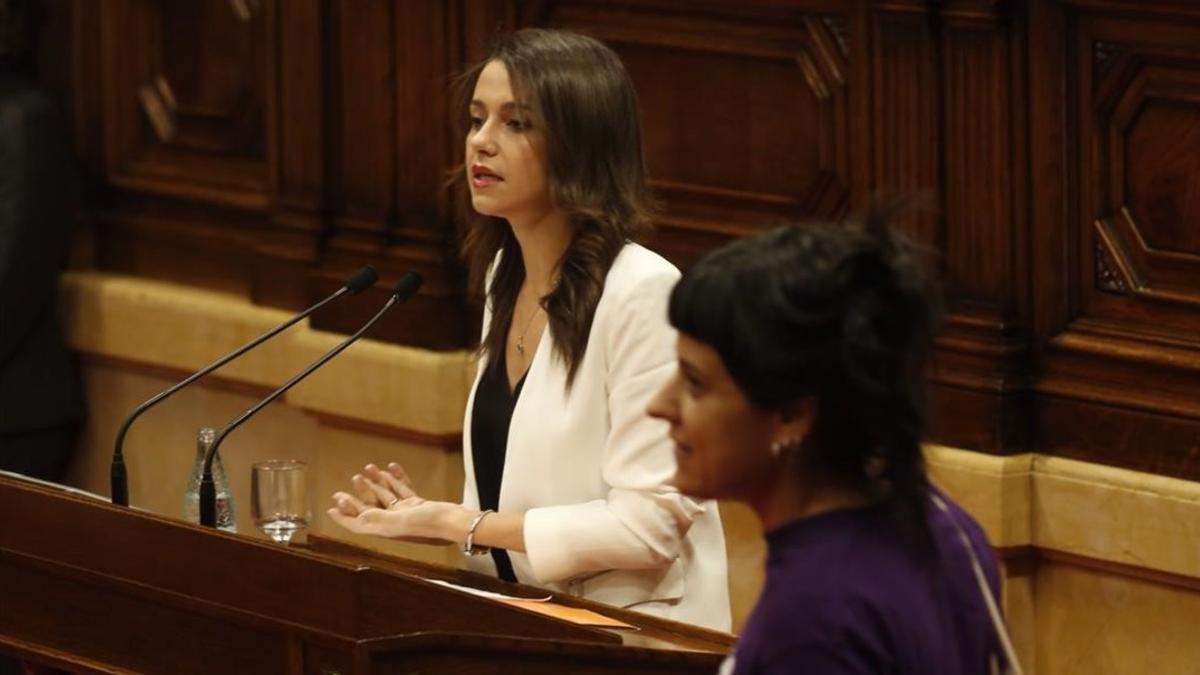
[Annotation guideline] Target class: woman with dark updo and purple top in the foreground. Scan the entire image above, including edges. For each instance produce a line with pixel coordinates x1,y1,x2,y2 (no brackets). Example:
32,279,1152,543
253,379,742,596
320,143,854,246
650,207,1015,675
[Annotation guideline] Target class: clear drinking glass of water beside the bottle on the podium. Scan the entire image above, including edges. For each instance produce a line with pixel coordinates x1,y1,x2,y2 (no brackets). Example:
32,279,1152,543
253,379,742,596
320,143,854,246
250,459,308,544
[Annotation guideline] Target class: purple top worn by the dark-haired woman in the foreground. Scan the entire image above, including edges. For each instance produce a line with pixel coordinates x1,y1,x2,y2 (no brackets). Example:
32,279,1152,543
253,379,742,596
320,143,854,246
722,492,1003,675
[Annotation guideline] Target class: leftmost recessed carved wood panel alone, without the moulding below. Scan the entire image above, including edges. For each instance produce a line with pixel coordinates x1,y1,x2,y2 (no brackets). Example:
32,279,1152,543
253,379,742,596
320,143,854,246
101,0,274,201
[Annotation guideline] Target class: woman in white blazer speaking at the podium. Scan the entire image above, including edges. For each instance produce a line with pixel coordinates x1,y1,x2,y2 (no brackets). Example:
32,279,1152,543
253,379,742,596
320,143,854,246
329,29,730,631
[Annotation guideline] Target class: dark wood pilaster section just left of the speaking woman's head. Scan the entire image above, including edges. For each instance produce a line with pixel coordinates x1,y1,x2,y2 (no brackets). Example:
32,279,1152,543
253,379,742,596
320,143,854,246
306,0,472,350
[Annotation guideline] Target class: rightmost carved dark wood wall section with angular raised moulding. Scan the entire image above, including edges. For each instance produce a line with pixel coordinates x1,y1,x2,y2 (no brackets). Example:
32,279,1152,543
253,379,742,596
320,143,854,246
1031,0,1200,478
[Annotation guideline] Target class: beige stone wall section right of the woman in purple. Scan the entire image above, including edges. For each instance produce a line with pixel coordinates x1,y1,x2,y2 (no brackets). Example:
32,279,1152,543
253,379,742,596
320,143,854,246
928,447,1200,674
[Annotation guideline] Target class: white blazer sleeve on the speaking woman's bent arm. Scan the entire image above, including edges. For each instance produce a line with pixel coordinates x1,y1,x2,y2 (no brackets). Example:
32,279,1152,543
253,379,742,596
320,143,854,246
524,268,704,584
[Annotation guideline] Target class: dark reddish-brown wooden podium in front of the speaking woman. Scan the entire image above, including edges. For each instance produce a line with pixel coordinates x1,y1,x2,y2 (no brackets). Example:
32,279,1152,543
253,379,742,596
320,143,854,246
0,476,732,675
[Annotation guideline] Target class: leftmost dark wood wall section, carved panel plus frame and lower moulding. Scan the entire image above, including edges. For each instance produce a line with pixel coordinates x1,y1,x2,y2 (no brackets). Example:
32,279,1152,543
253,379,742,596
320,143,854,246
88,0,325,306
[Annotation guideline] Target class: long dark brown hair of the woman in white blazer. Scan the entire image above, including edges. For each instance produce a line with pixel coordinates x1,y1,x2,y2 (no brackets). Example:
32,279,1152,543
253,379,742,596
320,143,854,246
454,29,650,386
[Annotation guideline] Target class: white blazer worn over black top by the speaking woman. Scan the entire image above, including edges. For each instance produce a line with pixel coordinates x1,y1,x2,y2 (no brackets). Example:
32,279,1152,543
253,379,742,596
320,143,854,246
463,244,731,631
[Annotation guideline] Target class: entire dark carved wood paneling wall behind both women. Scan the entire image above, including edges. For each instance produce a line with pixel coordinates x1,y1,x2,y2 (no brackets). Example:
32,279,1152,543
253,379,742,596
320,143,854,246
43,0,1200,478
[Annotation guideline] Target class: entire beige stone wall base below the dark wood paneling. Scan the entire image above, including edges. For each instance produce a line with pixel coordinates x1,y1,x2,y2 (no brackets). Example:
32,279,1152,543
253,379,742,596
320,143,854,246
62,273,1200,662
